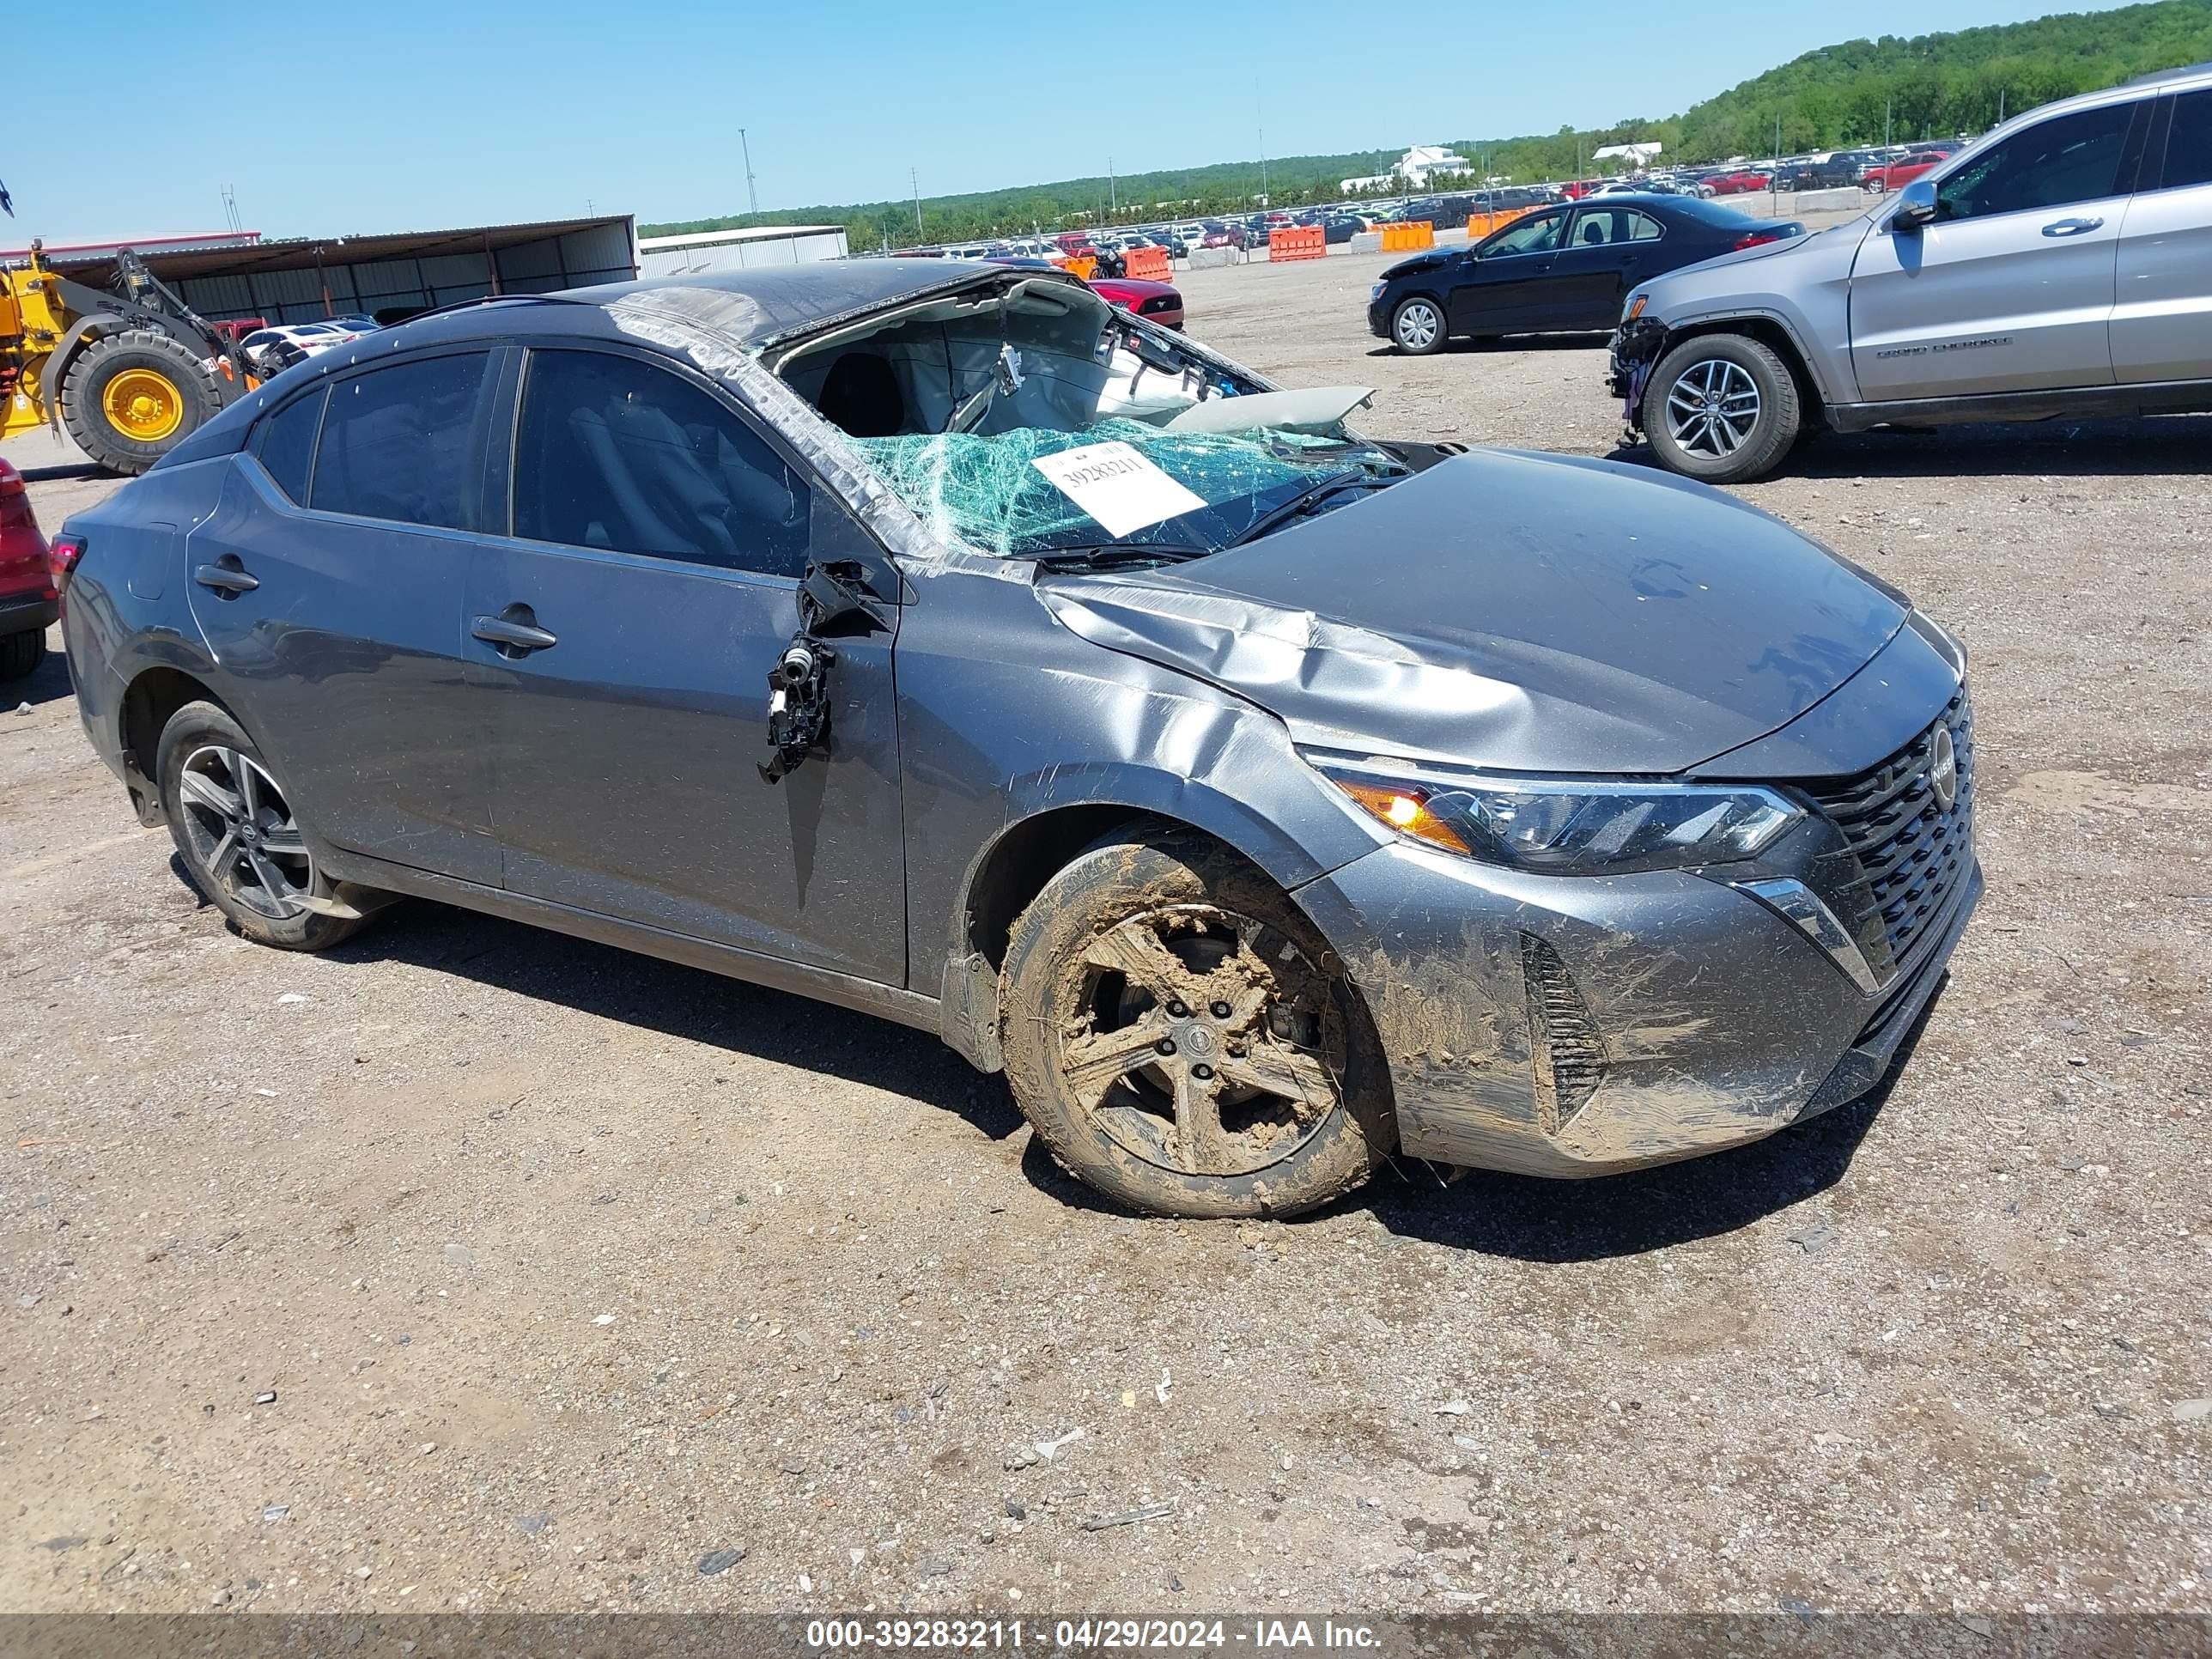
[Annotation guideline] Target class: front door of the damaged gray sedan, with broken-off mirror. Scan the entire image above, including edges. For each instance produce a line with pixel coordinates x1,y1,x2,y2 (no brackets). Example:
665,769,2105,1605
467,349,907,984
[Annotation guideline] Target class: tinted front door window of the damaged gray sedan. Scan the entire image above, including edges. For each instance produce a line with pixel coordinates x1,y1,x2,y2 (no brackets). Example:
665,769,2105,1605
515,352,807,577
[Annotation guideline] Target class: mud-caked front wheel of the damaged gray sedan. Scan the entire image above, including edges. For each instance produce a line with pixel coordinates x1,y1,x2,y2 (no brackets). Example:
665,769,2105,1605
1000,836,1394,1217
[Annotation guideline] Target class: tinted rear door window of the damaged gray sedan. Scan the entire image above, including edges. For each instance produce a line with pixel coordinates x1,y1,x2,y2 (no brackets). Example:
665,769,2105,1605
314,352,491,531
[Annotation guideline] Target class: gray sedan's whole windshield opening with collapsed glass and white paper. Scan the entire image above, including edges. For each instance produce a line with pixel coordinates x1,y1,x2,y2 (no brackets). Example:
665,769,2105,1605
779,283,1407,562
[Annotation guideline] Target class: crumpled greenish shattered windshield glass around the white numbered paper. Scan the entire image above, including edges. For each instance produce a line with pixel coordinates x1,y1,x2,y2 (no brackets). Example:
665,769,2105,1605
854,418,1402,557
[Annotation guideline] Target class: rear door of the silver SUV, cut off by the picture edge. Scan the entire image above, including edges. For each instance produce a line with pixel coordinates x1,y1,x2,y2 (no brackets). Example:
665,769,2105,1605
2112,91,2212,385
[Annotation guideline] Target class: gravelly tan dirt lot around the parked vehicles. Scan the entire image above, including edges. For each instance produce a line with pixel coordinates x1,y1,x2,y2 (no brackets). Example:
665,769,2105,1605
0,257,2212,1614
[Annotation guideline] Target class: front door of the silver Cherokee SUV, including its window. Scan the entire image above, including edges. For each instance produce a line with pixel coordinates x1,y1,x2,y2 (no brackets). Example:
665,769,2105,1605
1851,100,2148,403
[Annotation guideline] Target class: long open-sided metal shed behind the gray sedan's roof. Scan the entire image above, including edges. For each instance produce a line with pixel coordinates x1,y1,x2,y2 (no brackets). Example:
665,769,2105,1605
32,215,637,323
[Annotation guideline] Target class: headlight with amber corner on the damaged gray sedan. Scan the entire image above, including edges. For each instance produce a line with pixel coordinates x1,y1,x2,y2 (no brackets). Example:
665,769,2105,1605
1305,750,1805,876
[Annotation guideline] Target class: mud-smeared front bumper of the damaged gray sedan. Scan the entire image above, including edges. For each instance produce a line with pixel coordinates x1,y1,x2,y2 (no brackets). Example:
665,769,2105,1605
1298,842,1982,1176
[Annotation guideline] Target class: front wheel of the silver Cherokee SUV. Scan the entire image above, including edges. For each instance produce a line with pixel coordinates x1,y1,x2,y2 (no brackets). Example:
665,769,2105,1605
1644,334,1802,484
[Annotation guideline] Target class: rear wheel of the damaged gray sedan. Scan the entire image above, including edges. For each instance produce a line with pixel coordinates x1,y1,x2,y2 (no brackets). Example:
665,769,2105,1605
155,703,365,951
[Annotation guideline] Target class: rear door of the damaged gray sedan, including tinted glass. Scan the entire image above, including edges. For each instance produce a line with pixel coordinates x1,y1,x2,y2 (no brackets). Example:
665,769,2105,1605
185,345,500,884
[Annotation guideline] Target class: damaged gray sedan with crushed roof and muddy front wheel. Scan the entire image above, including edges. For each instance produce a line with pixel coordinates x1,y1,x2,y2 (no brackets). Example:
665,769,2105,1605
55,261,1982,1217
